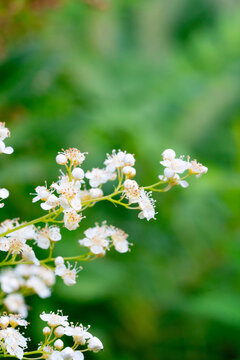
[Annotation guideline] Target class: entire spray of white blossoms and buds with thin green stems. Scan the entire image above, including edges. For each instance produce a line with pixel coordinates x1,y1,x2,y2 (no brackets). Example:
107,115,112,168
0,123,208,360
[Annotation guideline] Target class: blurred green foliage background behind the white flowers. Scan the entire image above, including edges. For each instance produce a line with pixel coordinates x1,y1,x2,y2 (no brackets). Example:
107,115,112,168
0,0,240,360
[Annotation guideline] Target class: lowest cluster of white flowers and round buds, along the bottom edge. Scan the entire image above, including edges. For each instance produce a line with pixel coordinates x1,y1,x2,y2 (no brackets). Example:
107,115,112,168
0,311,103,360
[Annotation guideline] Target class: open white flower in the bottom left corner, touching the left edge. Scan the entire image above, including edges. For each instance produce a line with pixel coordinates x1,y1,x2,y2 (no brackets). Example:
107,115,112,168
0,327,27,359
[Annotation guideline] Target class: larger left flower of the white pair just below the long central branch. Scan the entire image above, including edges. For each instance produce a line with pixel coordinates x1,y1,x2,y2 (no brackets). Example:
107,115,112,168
78,224,112,255
